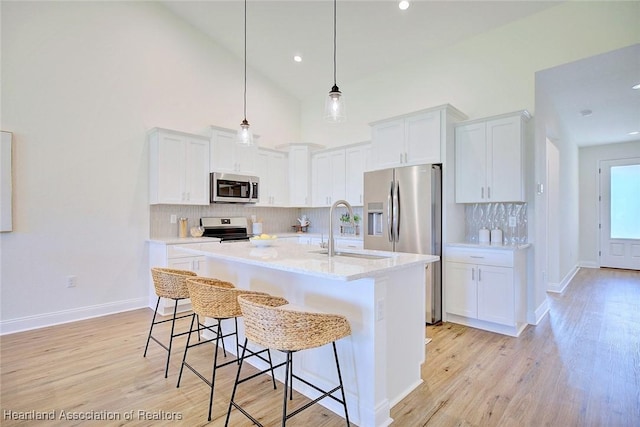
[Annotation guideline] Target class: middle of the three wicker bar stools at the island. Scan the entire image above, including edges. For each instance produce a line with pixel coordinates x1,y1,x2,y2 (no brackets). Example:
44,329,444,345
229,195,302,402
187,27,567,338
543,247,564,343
176,277,276,421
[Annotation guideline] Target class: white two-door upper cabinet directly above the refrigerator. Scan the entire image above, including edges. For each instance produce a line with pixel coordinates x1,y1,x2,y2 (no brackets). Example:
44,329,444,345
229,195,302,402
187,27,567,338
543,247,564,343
371,105,465,169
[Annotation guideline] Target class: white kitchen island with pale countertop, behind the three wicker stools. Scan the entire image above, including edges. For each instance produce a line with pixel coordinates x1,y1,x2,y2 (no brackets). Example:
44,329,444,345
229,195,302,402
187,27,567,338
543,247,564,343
176,241,439,427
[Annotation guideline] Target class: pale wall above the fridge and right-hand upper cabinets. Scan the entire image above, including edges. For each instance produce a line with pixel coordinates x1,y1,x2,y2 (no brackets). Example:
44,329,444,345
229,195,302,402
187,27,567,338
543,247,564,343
302,2,640,147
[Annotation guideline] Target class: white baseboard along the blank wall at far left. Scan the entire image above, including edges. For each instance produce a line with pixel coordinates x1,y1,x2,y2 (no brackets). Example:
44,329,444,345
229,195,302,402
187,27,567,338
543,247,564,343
0,297,149,335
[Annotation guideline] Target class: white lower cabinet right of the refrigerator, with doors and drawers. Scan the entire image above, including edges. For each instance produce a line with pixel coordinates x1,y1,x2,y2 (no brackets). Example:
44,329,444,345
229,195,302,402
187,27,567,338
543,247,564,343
444,247,527,336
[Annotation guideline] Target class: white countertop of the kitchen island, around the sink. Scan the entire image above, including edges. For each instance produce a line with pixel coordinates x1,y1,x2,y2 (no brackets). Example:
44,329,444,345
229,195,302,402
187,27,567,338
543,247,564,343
175,241,440,281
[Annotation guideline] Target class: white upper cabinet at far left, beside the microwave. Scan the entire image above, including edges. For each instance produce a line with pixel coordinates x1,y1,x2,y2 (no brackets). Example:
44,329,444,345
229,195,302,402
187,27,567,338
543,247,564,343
148,128,209,205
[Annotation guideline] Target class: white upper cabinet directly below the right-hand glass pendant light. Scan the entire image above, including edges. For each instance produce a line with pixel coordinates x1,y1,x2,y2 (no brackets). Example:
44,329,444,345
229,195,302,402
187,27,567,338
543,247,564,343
311,148,346,207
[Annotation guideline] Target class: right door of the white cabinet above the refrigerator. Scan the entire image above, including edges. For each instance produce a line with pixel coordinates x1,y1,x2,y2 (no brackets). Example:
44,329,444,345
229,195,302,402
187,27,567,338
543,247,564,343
404,111,442,164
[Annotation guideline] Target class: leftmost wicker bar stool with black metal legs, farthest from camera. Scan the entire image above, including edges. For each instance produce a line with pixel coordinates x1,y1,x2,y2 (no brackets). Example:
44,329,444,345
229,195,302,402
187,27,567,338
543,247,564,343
143,267,196,378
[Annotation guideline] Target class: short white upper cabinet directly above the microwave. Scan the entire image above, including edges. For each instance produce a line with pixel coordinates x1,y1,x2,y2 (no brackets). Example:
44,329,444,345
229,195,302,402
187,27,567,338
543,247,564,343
209,126,258,175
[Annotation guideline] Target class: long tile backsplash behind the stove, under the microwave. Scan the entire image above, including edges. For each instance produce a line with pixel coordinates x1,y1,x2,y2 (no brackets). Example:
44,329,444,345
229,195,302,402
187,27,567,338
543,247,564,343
149,203,362,238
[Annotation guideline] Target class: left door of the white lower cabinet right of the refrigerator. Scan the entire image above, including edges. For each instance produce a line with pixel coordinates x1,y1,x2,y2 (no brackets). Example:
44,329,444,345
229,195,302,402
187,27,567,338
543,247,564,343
445,262,478,319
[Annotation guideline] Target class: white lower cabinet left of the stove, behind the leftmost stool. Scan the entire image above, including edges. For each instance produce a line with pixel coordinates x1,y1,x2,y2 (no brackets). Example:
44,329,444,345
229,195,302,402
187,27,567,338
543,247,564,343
149,241,208,316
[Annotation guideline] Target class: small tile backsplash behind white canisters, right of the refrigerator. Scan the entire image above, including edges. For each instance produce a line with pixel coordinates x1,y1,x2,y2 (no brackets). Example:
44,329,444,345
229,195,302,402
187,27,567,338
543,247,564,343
465,203,528,245
